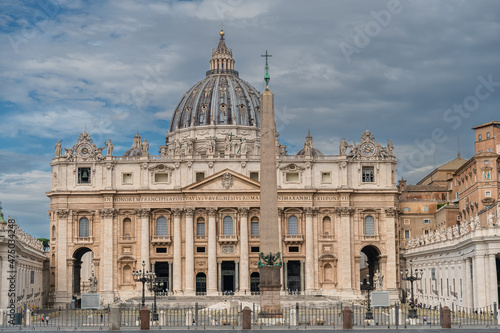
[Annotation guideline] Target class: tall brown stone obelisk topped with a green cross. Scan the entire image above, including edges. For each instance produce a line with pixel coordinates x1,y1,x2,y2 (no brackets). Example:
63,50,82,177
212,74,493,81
259,51,282,317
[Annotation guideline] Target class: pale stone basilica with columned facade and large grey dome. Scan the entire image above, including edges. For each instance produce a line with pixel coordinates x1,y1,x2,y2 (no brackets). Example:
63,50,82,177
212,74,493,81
48,30,398,303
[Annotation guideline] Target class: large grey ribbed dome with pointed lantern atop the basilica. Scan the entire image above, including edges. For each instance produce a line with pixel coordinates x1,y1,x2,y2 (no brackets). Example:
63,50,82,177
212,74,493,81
169,31,260,132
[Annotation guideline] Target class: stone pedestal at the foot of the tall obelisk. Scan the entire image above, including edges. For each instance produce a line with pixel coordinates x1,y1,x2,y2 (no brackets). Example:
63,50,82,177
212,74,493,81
259,266,283,325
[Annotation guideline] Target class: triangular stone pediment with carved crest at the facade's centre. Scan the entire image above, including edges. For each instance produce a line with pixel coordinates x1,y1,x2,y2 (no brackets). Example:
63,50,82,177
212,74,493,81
183,169,260,192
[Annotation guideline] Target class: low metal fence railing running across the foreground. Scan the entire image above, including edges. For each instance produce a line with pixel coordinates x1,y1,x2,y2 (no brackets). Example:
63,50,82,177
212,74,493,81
0,303,499,331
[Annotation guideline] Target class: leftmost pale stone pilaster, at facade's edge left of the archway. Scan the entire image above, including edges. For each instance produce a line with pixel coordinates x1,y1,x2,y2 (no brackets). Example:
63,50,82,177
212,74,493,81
55,209,73,303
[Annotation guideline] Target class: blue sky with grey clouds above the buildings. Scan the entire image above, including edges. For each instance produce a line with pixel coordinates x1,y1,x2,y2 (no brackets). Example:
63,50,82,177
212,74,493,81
0,0,500,237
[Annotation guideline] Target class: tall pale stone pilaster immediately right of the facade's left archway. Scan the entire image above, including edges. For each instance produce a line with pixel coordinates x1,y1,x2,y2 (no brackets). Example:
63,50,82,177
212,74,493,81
99,208,117,302
